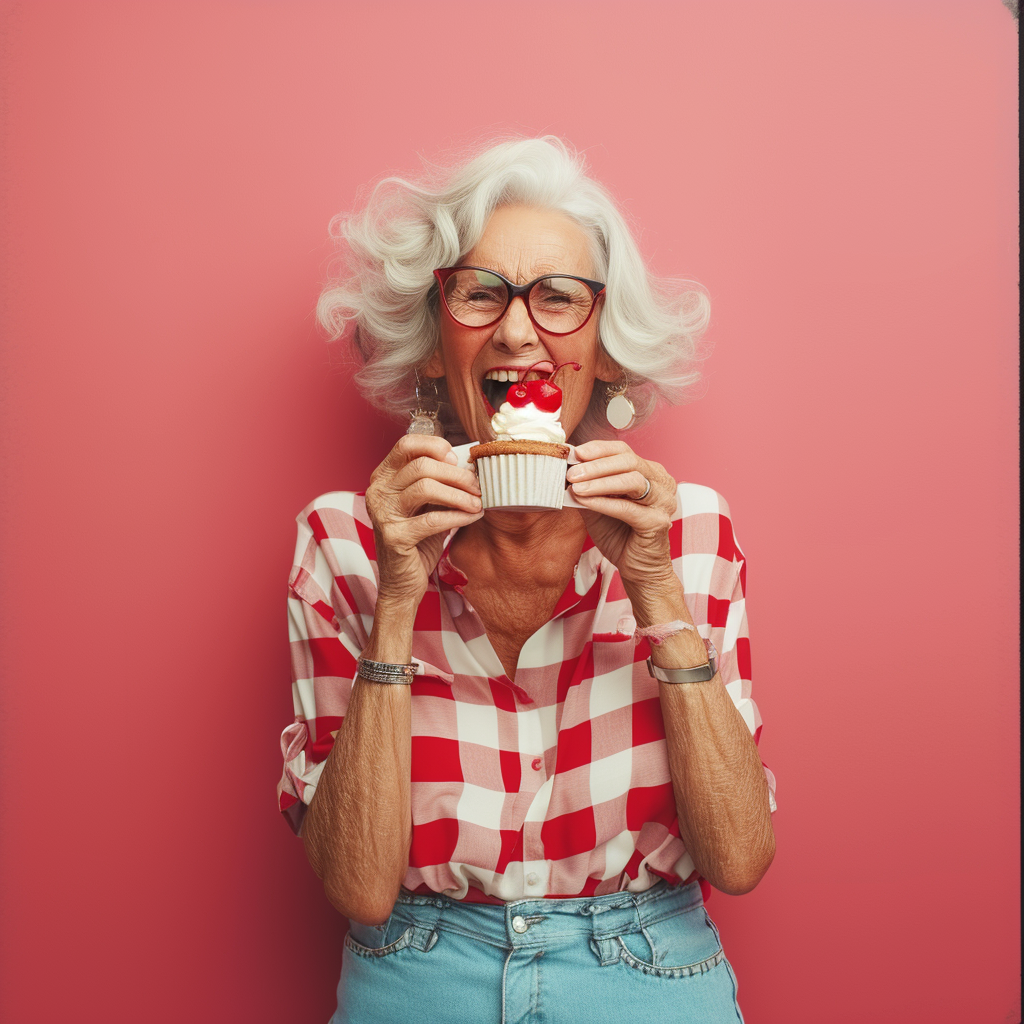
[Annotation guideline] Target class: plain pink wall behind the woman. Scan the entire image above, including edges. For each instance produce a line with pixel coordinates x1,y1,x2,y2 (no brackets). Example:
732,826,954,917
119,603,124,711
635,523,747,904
0,0,1020,1024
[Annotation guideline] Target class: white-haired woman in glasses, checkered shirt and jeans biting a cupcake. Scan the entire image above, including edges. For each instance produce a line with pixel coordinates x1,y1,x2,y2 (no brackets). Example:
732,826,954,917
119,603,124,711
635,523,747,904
280,138,774,1024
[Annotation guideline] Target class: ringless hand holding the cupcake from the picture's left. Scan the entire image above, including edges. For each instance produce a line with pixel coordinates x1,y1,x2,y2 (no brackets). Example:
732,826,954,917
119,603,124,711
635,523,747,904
367,434,483,607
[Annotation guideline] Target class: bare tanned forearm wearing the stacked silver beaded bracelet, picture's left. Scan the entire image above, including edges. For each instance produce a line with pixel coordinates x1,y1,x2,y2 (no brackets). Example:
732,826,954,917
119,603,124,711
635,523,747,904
302,608,415,924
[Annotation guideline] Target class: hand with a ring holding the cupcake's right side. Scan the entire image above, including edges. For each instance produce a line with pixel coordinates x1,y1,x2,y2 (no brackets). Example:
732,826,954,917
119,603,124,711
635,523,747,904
566,440,676,585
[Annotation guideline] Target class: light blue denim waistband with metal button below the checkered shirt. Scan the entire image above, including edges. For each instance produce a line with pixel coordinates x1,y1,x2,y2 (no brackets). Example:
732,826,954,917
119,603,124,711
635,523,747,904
393,881,703,949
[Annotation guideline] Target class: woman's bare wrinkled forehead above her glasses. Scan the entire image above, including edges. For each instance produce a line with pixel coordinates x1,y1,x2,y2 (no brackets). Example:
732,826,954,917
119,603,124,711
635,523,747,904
461,206,594,285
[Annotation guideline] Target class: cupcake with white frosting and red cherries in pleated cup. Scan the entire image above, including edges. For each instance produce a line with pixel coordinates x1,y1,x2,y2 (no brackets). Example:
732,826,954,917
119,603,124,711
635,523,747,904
469,362,580,509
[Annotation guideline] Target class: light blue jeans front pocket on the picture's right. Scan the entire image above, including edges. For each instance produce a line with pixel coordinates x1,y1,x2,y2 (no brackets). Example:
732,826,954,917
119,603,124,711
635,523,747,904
615,906,725,978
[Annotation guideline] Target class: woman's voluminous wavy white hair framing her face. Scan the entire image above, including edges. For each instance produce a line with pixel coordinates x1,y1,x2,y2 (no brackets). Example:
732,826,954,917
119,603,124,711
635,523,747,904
316,135,711,443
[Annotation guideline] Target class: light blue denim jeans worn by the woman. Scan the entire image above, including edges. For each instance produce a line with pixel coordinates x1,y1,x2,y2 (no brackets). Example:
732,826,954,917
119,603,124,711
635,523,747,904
330,882,743,1024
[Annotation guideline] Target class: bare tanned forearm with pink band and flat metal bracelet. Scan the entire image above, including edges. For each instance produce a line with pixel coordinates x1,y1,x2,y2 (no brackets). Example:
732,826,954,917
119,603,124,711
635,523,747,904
627,577,775,894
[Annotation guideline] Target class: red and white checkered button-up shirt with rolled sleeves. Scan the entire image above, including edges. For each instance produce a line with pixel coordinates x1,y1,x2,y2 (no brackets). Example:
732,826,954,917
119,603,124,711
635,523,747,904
279,483,775,900
